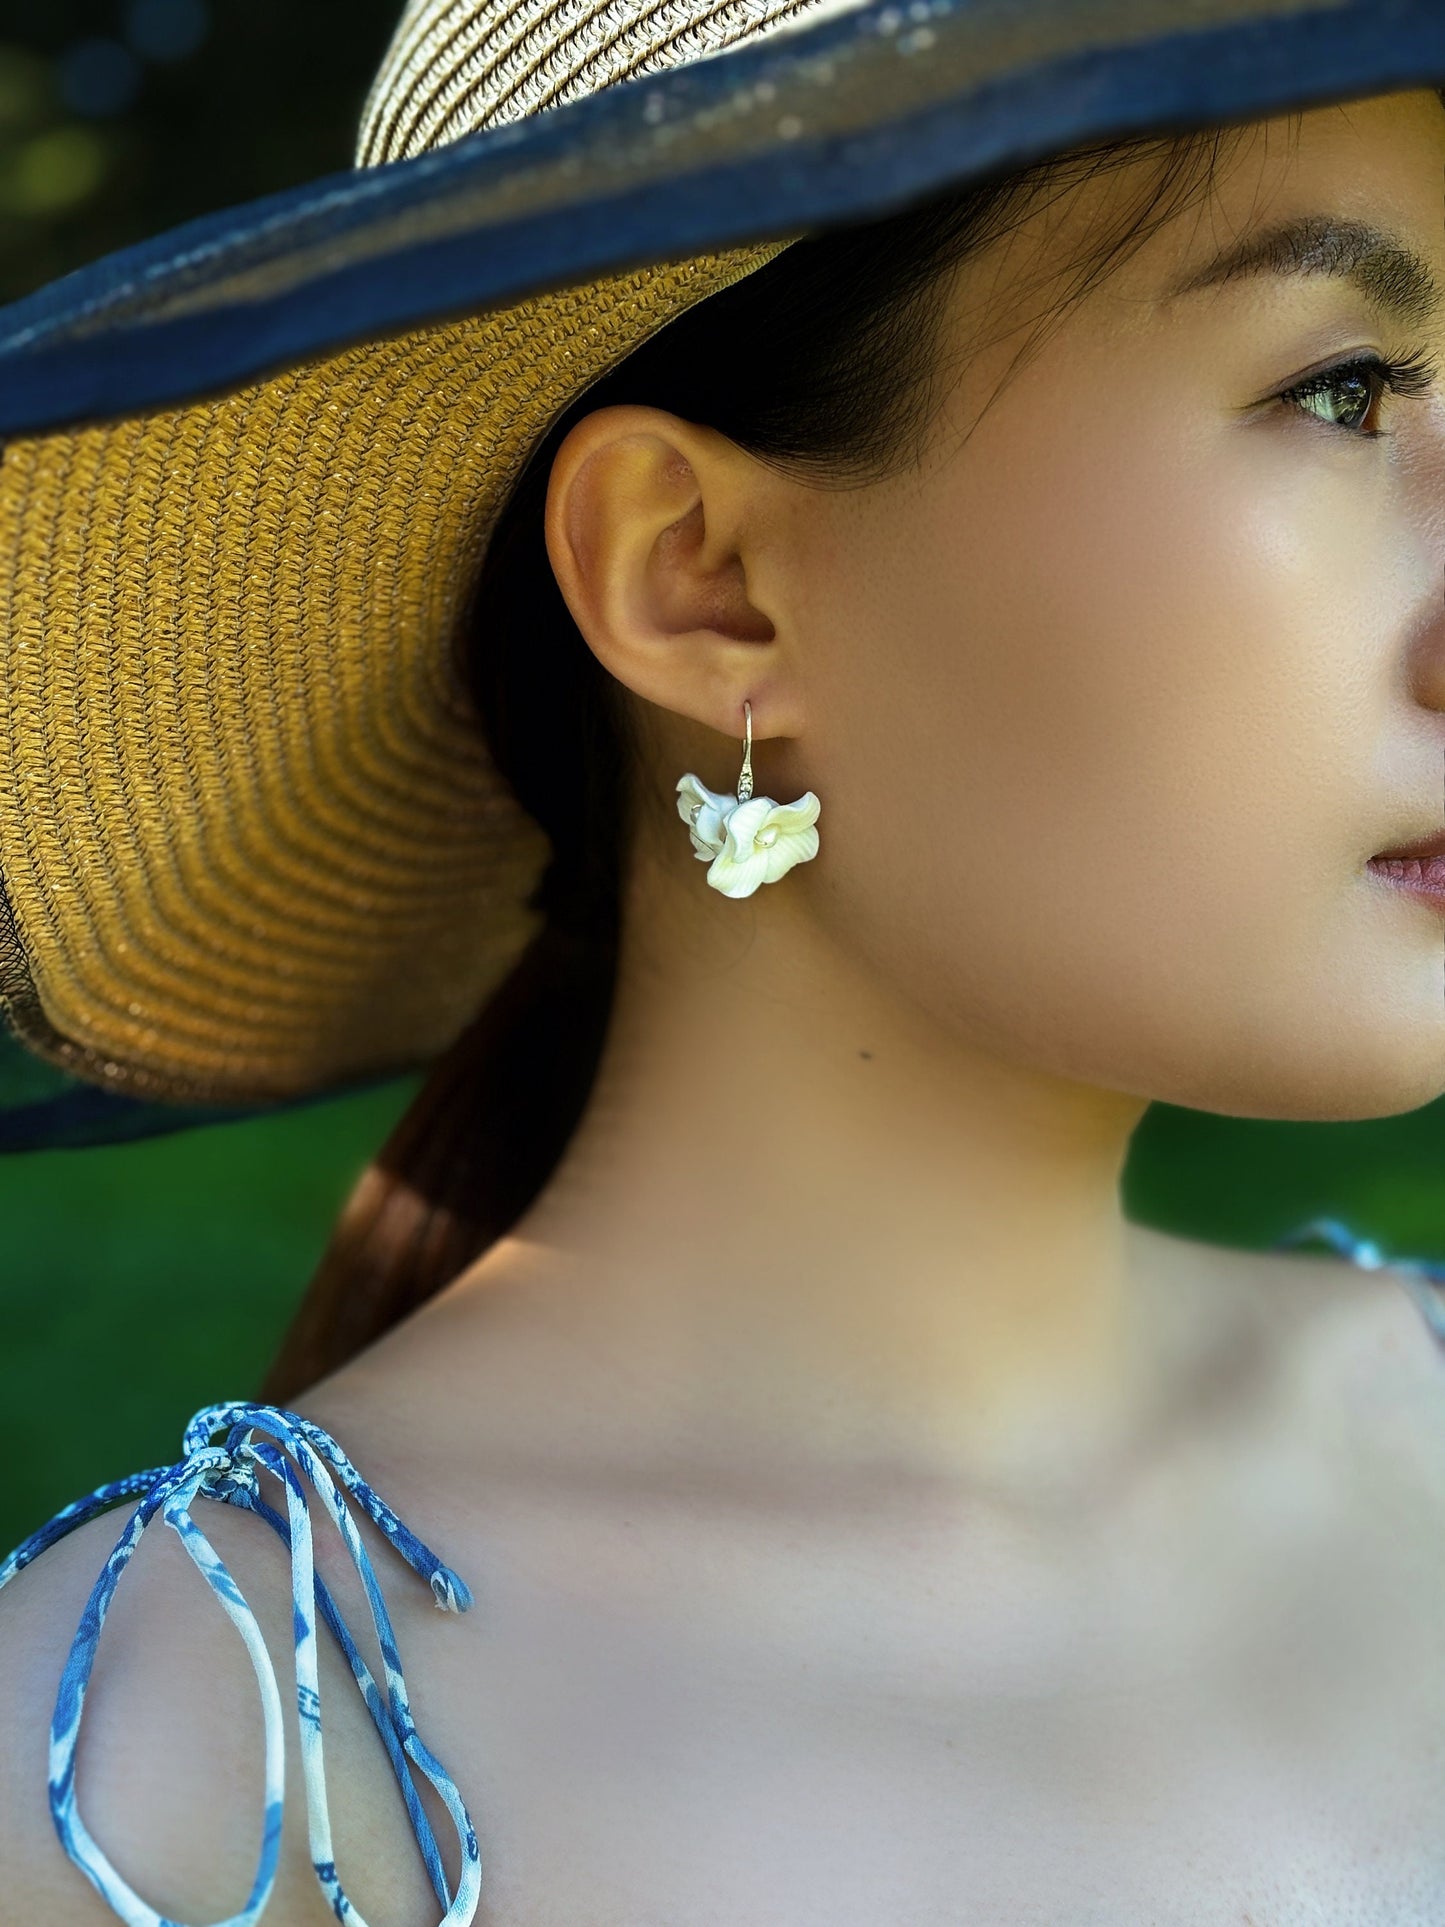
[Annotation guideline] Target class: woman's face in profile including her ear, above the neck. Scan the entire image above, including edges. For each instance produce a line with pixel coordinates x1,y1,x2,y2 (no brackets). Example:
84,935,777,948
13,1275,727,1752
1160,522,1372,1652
547,91,1445,1120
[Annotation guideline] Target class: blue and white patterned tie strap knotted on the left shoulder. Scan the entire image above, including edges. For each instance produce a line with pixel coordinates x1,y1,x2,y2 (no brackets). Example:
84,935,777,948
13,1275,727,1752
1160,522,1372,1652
0,1401,482,1927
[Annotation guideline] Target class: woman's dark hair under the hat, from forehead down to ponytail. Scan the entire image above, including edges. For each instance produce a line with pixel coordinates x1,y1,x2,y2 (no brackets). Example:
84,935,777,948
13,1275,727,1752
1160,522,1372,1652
262,116,1263,1403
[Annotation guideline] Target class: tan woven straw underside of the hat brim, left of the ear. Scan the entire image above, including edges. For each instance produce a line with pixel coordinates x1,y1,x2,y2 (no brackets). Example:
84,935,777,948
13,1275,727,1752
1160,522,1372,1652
0,241,788,1102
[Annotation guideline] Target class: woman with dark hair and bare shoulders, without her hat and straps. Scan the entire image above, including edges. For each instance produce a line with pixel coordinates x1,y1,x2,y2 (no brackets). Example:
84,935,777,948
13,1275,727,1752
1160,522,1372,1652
0,0,1445,1927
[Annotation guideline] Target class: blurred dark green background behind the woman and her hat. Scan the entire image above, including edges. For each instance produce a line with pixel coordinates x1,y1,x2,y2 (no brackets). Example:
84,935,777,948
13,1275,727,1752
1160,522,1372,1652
0,0,1445,1551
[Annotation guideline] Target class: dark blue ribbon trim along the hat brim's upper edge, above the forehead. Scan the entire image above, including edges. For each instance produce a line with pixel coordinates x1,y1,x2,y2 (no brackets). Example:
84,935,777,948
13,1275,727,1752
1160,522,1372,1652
0,0,1445,437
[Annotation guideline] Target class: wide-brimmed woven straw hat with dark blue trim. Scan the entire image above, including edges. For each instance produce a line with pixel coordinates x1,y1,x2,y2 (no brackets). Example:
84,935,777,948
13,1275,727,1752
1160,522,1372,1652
0,0,1445,1141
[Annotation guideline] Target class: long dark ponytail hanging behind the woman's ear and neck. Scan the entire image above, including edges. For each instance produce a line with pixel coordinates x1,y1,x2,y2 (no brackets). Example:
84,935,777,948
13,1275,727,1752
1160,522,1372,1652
260,402,630,1405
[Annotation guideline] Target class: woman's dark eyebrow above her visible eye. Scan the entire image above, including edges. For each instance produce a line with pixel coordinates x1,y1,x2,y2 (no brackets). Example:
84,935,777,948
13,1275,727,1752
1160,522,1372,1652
1166,214,1441,326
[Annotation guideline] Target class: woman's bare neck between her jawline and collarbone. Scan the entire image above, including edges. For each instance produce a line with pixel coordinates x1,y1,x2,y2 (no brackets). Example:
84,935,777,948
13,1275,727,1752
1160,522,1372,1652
453,847,1186,1490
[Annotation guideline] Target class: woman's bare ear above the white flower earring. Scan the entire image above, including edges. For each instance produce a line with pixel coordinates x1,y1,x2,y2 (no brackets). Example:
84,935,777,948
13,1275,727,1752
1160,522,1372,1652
545,405,816,736
